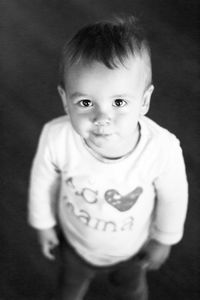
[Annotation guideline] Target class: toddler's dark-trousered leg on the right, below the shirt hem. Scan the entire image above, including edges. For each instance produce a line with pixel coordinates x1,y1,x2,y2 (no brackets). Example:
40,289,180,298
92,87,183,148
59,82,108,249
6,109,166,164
109,258,148,300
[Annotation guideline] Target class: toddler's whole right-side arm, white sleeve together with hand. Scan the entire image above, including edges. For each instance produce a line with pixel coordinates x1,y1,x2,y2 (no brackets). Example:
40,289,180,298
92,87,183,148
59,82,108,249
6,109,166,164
141,139,188,270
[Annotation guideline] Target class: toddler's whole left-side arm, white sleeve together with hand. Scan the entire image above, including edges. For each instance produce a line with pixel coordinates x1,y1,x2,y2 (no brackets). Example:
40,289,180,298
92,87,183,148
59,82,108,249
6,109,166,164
28,126,60,259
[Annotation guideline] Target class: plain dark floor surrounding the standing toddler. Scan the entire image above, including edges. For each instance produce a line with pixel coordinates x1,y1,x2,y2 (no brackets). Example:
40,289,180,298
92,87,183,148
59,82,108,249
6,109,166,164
0,0,200,300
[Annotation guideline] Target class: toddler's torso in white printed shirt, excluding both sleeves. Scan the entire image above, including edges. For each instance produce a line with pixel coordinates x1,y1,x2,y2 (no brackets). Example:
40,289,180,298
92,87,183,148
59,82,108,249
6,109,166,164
51,115,170,265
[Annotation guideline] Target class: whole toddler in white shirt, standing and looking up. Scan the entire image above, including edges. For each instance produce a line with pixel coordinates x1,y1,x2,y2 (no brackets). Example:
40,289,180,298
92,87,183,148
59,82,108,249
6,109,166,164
29,16,188,300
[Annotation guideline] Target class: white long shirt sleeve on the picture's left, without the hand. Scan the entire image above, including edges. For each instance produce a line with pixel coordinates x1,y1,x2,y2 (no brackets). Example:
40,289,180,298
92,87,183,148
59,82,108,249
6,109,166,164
28,124,60,229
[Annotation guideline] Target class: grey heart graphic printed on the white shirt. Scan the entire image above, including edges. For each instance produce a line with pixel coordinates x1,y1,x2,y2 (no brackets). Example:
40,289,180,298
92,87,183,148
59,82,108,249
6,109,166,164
104,187,143,211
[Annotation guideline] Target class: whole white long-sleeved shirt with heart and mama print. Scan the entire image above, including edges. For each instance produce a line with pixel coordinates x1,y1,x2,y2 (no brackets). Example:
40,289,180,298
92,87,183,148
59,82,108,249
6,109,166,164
29,116,188,265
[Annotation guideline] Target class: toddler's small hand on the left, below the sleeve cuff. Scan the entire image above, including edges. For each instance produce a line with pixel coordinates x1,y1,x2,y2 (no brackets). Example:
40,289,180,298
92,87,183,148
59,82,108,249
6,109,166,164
38,228,59,260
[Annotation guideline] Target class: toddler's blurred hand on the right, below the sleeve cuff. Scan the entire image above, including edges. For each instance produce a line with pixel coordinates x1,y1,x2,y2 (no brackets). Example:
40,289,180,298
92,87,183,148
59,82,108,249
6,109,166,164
141,240,171,270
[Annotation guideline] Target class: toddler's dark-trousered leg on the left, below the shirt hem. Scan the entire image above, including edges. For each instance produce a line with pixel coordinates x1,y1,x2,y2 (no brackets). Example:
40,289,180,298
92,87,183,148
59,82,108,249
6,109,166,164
58,239,95,300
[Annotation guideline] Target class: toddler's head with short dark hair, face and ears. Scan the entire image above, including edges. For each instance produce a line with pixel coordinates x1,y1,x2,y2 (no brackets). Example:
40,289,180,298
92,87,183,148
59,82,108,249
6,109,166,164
58,17,153,157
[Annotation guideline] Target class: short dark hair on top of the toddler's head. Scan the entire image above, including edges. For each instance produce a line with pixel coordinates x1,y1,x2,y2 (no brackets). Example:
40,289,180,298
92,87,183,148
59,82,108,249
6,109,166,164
60,16,151,88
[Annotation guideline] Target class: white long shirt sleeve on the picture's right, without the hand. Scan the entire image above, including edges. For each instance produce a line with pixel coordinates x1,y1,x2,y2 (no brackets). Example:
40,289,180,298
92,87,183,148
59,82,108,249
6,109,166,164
152,135,188,244
